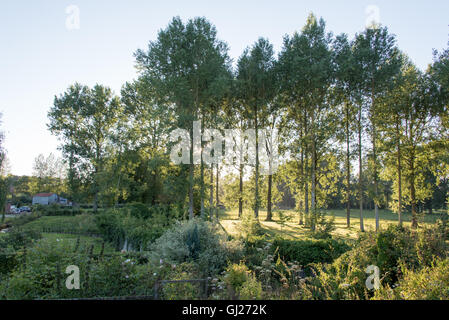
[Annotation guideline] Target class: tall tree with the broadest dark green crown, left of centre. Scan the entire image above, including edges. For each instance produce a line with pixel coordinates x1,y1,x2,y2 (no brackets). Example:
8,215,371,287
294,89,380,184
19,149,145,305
135,17,229,218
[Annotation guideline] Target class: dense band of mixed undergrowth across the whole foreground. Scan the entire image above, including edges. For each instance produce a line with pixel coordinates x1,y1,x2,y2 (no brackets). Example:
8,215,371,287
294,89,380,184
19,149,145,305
0,203,449,299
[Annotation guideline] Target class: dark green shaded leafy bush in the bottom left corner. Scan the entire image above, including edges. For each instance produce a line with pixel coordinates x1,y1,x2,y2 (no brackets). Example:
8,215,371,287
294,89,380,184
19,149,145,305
0,239,155,299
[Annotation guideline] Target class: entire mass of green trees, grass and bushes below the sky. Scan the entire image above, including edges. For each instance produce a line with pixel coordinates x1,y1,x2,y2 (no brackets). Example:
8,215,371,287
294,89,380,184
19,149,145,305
0,14,449,299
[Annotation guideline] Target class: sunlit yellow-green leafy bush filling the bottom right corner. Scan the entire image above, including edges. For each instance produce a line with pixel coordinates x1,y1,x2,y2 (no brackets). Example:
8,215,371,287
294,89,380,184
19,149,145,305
302,226,447,300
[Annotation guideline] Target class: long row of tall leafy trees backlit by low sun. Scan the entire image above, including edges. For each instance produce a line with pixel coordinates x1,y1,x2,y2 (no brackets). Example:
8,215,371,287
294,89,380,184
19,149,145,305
49,15,449,231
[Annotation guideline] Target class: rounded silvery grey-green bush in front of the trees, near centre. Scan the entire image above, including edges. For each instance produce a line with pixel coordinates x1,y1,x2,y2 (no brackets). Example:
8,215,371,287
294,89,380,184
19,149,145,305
150,219,243,276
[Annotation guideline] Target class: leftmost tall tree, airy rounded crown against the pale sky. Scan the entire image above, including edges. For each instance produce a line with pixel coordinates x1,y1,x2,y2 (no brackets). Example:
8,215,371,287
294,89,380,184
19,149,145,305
48,84,121,210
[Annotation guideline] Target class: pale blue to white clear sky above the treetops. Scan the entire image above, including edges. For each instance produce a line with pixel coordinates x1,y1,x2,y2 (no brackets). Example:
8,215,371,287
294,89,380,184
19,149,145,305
0,0,449,175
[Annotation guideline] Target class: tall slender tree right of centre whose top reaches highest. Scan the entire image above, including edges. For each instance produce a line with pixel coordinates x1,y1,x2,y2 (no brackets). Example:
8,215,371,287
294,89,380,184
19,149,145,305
280,15,334,230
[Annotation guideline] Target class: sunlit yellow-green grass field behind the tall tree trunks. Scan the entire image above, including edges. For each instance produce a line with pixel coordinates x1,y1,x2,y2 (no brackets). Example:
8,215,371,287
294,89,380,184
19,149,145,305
219,209,443,239
